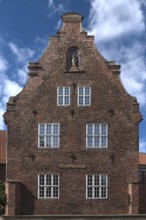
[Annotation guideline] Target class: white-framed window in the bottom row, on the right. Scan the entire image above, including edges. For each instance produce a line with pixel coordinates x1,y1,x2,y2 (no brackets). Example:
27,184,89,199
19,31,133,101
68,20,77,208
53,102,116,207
86,174,108,199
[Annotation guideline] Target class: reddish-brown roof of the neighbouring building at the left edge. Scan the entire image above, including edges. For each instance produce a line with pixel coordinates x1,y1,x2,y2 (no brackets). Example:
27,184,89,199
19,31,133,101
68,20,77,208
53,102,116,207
0,131,7,164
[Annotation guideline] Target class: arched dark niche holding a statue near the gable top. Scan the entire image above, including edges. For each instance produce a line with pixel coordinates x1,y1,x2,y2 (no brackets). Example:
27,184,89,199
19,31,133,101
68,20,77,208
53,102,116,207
66,46,80,71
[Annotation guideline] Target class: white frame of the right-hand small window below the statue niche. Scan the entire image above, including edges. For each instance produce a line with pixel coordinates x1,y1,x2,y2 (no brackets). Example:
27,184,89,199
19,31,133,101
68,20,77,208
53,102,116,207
78,86,91,106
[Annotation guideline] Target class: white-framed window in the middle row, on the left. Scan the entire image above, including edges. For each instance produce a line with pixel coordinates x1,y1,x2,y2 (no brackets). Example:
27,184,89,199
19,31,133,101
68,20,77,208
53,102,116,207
38,123,60,148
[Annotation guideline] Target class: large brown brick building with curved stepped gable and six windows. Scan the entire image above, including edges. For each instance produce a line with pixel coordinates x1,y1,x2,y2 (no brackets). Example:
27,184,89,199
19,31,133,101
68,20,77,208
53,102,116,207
4,13,141,215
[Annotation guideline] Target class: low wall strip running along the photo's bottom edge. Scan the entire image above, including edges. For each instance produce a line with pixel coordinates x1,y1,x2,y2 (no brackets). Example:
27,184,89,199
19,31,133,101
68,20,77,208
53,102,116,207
0,215,146,220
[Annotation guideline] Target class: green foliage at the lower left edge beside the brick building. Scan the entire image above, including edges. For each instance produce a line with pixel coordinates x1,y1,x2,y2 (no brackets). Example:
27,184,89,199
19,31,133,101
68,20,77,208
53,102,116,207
0,181,6,215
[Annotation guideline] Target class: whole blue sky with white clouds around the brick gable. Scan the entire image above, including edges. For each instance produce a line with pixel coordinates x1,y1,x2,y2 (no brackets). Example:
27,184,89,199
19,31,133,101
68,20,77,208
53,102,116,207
0,0,146,152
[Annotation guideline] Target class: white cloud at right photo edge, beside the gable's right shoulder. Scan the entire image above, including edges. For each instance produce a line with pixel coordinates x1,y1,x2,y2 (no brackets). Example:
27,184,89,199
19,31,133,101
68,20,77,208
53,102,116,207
119,42,146,106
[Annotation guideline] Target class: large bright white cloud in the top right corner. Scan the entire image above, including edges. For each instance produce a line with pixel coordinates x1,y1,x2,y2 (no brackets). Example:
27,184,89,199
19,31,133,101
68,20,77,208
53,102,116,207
89,0,144,41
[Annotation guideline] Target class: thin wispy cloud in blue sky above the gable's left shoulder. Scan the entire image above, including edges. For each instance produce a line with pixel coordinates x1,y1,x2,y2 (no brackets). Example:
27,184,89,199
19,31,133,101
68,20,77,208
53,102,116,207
8,42,35,63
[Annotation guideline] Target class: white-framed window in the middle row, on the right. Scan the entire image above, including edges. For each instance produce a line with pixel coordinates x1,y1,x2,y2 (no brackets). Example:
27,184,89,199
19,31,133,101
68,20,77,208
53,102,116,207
86,124,108,148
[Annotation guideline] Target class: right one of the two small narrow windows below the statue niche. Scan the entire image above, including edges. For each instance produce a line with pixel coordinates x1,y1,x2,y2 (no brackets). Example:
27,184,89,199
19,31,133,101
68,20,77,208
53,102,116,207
78,86,91,106
